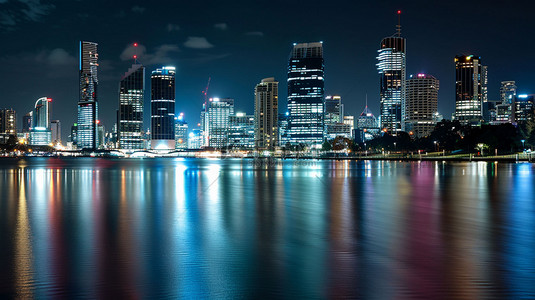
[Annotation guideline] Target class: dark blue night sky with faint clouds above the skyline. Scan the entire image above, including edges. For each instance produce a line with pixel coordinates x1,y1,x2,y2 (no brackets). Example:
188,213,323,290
0,0,535,138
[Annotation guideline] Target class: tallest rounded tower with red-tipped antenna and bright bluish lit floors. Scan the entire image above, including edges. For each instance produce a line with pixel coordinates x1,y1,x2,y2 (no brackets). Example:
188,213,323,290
377,11,407,135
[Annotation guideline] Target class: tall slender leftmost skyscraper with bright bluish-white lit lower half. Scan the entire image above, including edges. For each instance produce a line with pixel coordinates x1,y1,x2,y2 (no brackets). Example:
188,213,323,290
77,41,98,149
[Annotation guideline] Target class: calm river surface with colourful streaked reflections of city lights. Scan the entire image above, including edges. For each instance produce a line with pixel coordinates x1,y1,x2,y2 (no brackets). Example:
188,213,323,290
0,158,535,299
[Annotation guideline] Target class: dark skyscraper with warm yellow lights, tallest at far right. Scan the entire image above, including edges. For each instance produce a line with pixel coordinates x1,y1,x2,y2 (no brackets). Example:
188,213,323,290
455,55,487,125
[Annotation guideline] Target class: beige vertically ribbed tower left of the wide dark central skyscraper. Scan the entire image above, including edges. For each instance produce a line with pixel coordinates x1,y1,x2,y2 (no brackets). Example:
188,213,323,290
254,77,279,150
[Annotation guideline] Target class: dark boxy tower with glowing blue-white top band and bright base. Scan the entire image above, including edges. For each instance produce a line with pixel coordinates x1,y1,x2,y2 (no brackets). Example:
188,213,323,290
151,67,175,150
